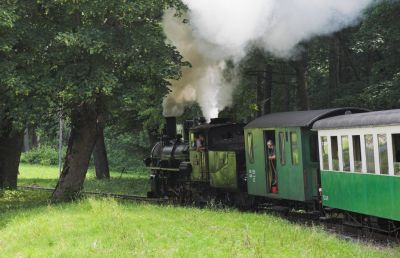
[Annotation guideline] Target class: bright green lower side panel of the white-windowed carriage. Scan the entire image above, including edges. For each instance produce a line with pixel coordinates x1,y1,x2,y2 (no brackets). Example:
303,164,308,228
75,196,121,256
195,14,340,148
321,170,400,221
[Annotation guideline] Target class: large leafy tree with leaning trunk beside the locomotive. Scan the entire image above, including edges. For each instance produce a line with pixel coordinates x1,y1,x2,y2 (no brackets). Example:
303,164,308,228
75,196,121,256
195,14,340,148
31,0,186,200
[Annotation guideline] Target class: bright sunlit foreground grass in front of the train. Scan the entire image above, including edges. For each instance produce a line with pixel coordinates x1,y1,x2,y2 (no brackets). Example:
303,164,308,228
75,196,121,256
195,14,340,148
0,191,400,257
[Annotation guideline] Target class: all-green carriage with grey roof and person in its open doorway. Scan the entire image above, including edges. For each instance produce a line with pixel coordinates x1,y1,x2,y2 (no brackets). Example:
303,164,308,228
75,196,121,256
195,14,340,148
244,108,364,202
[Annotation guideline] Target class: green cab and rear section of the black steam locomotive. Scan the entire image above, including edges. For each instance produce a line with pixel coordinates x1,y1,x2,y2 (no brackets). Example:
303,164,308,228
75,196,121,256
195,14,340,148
189,123,245,191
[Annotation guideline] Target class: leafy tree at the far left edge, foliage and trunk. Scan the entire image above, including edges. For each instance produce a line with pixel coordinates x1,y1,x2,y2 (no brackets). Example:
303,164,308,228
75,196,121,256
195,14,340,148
0,0,51,188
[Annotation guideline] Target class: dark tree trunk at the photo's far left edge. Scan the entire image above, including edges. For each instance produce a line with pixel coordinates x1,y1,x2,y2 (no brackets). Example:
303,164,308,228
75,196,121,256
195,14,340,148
0,123,24,189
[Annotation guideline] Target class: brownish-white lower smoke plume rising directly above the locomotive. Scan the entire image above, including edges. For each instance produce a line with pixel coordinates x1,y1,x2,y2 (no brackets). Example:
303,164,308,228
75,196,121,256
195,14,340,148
163,11,235,120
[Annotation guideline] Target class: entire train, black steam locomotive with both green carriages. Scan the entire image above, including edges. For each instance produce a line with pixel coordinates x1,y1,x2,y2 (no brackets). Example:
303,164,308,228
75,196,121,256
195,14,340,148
145,108,400,232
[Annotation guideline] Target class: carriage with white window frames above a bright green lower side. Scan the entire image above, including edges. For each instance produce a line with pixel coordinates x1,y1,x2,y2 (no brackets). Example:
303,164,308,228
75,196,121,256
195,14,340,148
314,110,400,221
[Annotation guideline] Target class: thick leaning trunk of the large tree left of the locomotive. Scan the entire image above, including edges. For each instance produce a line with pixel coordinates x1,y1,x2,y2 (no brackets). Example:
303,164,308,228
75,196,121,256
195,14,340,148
52,104,98,201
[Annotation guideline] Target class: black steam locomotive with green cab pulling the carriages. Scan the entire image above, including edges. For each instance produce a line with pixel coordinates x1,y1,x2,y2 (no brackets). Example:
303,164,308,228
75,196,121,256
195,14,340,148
145,117,247,206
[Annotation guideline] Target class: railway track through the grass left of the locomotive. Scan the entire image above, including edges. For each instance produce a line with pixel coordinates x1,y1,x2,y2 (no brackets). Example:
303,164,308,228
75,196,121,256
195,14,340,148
18,186,168,203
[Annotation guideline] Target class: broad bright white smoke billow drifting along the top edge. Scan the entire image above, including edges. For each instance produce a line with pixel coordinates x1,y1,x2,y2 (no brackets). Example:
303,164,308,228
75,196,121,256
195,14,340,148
183,0,376,58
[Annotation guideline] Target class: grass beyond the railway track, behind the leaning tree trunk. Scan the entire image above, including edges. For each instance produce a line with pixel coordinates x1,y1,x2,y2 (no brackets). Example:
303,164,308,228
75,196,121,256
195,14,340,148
18,164,149,196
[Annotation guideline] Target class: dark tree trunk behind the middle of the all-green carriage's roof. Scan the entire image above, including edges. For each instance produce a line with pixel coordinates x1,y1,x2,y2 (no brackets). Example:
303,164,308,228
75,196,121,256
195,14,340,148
292,56,309,110
